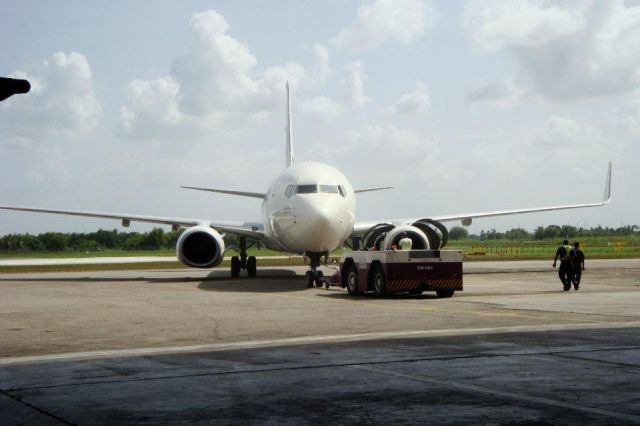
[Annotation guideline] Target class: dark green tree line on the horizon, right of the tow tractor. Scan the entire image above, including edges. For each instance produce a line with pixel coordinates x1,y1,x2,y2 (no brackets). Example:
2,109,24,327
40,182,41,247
449,225,640,241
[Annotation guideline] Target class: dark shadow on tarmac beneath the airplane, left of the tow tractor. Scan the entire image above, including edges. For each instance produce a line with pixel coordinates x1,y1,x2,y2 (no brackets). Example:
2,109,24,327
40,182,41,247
198,269,307,293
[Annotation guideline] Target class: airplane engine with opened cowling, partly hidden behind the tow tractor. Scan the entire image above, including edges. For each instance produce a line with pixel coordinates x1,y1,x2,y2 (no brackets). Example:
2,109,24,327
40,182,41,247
362,219,449,250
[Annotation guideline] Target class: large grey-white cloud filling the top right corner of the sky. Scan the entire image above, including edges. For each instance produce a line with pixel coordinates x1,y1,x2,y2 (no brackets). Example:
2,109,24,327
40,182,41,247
462,0,640,100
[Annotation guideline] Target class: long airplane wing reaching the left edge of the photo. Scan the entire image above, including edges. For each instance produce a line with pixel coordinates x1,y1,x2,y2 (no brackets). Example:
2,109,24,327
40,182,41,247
0,206,264,240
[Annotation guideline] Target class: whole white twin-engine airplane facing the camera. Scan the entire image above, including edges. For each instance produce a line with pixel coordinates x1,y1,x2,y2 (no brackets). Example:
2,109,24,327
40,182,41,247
0,83,611,286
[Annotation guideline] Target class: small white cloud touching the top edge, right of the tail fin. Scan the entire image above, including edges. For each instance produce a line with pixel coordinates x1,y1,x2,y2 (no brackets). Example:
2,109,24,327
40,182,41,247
331,0,438,52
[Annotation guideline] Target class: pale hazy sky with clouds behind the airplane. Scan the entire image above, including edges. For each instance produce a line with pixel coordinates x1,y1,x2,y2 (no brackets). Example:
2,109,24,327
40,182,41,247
0,0,640,234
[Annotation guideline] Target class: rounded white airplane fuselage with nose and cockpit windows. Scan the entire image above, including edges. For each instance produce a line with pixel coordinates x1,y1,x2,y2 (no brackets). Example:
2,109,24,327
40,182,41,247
262,161,356,254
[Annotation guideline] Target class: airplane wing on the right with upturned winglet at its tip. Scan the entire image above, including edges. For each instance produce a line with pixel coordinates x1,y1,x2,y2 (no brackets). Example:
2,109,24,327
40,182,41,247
353,163,611,235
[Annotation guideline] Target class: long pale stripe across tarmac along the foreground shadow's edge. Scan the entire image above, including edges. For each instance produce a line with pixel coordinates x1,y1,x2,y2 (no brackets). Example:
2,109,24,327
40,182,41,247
0,321,640,365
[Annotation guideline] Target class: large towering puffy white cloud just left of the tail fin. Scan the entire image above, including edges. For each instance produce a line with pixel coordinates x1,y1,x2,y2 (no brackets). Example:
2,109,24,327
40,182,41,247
121,10,310,136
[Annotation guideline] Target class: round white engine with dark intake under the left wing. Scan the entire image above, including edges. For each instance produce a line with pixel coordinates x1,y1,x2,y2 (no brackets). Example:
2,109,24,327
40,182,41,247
176,226,224,268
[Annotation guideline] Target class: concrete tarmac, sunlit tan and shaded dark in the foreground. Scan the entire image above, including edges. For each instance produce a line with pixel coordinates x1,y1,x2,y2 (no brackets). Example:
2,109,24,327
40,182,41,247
0,260,640,424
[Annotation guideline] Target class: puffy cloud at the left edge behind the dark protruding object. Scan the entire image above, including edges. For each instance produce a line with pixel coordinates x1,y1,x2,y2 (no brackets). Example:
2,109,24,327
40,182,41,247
0,52,101,146
